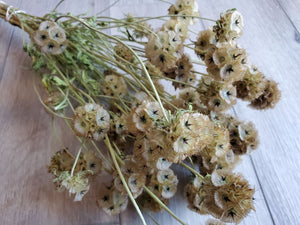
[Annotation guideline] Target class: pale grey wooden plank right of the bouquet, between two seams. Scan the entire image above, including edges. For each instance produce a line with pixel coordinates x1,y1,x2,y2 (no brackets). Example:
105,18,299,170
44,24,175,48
197,0,300,225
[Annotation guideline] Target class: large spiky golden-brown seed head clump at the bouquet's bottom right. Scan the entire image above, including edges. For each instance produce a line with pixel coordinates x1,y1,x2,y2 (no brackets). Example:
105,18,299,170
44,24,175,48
185,171,254,223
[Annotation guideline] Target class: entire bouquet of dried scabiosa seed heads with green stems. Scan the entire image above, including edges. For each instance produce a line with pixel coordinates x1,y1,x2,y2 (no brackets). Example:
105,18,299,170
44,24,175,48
0,0,280,224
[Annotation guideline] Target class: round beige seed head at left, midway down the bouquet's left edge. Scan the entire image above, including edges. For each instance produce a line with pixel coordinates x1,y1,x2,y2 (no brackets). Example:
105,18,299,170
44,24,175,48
72,103,110,141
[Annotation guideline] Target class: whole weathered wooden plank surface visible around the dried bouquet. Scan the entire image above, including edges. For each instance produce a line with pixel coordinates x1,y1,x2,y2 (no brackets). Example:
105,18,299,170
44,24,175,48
0,0,300,225
